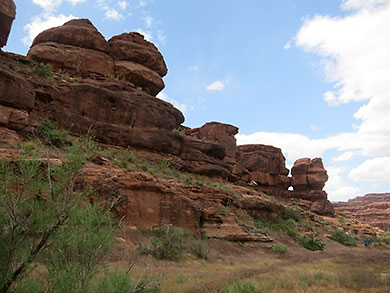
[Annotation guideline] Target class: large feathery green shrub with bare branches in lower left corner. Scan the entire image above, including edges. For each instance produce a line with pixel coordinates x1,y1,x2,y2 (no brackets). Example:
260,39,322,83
0,140,116,292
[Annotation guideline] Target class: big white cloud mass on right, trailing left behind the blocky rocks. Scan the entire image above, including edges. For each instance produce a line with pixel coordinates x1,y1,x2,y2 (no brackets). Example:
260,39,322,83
237,0,390,201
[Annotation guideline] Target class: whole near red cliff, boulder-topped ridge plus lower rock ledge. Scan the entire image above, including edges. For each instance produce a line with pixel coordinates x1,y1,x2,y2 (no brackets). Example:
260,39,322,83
0,2,333,241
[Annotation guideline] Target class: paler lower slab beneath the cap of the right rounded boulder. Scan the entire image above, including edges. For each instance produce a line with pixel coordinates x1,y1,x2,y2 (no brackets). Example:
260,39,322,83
115,61,165,96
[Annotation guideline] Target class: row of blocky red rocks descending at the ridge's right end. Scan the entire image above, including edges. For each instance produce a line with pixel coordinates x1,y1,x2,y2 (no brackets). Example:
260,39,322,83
185,122,334,215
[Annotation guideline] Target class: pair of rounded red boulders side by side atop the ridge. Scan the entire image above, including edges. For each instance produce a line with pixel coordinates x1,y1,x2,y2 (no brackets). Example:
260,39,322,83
28,19,167,96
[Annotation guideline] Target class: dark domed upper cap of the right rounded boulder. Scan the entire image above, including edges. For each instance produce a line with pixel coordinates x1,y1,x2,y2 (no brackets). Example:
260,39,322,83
108,32,168,77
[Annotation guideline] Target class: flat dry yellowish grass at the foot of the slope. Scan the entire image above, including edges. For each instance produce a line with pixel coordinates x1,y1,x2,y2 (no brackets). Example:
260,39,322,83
111,232,390,292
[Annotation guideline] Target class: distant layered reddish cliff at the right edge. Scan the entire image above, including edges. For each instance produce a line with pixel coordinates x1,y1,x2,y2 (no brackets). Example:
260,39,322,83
333,193,390,231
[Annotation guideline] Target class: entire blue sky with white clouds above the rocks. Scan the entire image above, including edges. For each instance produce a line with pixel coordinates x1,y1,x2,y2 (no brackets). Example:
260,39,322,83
3,0,390,201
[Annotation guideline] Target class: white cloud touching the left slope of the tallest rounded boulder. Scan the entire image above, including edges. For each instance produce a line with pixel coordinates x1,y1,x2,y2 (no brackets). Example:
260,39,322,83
22,14,77,46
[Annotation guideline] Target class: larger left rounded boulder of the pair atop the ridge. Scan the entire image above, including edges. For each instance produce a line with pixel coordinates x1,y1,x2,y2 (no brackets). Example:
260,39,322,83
28,19,114,76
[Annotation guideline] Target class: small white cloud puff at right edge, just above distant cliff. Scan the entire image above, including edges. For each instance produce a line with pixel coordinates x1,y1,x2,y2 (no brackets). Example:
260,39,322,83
348,157,390,182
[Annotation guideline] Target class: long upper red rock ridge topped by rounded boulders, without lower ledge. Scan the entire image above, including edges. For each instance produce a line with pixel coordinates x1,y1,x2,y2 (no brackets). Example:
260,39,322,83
0,0,334,222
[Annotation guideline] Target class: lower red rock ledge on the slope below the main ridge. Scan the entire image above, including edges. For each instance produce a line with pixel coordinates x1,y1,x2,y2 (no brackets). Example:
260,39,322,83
79,163,272,241
